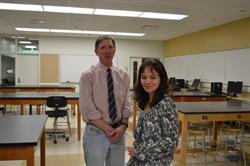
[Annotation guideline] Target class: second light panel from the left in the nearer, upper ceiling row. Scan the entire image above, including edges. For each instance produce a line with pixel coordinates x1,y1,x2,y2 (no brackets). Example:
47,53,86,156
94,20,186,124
43,5,94,14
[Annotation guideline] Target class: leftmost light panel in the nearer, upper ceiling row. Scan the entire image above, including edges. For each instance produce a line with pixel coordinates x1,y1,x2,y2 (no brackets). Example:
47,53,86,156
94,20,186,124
0,3,43,12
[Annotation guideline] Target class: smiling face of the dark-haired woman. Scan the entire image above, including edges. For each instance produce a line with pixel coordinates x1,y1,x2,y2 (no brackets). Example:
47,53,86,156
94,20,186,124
140,67,161,97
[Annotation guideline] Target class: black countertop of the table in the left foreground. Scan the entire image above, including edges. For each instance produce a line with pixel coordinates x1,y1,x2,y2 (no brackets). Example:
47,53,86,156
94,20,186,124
0,115,47,147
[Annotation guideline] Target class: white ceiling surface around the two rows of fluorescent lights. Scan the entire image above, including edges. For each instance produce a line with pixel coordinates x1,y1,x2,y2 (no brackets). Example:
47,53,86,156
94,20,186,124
0,0,250,40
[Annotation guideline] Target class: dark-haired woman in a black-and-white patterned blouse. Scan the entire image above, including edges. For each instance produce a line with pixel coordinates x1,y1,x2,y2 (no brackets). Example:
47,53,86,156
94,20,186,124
127,59,179,166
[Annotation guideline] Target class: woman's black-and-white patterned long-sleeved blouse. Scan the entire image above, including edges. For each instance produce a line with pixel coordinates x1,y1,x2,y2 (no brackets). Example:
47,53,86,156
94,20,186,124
127,96,179,166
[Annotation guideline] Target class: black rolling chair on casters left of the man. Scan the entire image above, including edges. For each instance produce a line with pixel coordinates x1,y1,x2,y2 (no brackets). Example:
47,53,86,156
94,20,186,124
45,96,71,144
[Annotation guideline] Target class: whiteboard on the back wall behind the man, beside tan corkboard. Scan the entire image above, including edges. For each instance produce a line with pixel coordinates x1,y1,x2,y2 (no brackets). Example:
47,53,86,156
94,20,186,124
60,55,118,83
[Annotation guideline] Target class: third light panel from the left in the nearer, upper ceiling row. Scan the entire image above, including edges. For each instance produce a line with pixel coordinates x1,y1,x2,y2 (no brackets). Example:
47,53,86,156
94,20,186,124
93,9,142,17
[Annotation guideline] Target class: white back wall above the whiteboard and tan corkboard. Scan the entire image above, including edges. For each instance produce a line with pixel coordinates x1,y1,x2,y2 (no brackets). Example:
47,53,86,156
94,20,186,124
39,37,165,83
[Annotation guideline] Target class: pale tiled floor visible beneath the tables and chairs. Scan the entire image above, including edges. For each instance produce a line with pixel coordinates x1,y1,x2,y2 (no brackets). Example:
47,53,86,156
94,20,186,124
0,110,250,166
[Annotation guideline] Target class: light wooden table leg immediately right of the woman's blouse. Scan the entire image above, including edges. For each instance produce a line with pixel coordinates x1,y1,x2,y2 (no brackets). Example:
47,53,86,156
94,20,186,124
179,116,188,166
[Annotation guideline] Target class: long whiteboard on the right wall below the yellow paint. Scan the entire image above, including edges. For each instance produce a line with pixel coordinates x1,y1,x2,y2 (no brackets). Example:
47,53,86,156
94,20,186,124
164,49,250,86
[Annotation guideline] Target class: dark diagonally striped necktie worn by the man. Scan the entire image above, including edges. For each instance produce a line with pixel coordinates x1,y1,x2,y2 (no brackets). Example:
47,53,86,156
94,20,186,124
107,69,117,121
